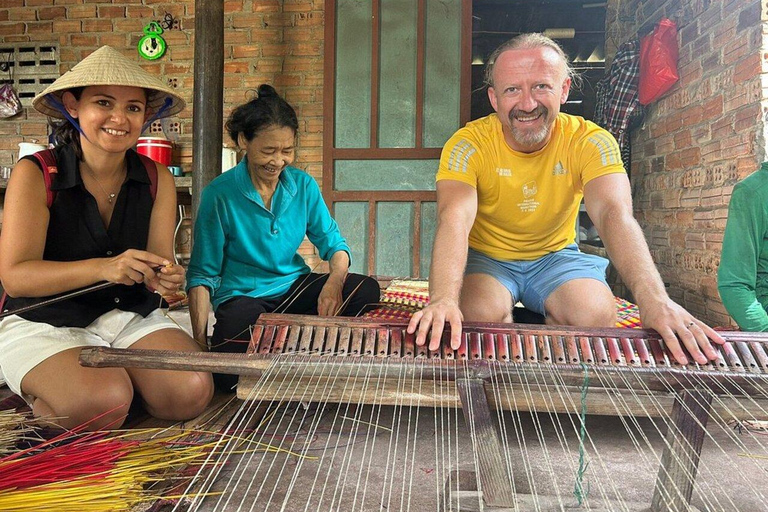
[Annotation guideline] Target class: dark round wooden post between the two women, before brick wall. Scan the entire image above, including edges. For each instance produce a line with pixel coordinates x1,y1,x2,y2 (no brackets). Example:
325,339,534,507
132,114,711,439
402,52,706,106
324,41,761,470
192,0,224,219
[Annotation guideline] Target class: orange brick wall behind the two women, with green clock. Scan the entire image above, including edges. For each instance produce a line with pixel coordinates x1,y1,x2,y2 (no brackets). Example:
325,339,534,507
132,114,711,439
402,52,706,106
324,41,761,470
0,0,324,265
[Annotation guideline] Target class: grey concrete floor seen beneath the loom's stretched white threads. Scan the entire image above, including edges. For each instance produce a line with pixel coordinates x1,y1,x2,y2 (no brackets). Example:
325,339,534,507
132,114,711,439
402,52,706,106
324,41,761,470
182,404,768,512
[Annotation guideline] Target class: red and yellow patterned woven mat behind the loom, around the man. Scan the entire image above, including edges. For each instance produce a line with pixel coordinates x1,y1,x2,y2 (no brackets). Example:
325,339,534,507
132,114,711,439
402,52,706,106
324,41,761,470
364,279,642,329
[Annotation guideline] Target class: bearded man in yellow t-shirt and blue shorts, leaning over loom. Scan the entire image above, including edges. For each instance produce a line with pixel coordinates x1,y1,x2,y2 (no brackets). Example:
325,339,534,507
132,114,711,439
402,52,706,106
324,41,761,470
408,34,724,364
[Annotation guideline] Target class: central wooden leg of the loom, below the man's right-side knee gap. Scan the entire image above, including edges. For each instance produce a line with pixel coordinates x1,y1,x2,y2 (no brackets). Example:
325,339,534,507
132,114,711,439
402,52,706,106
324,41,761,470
456,379,515,507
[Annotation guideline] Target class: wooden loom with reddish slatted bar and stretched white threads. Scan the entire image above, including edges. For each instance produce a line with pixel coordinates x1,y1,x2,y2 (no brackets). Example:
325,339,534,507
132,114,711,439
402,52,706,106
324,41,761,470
82,314,768,512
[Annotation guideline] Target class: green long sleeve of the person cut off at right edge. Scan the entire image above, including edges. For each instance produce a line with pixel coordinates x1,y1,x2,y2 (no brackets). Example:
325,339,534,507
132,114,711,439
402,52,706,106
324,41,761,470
717,162,768,332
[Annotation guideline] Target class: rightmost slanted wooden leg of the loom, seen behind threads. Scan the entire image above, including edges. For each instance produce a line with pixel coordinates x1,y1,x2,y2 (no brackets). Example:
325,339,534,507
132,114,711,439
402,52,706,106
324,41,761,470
651,391,712,512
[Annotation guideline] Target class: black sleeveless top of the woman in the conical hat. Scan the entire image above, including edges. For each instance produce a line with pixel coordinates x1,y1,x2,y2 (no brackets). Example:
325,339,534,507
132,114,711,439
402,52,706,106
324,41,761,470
5,146,160,327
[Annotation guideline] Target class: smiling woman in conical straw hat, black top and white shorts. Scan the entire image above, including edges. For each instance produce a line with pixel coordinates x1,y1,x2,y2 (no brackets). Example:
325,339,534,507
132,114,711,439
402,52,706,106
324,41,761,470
0,46,213,429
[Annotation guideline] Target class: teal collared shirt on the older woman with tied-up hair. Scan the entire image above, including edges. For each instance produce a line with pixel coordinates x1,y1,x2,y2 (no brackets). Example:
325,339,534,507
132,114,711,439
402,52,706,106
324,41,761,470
187,158,351,310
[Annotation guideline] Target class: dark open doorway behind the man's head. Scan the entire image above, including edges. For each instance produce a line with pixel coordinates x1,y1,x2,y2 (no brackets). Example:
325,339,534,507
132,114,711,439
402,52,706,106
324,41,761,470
471,0,607,119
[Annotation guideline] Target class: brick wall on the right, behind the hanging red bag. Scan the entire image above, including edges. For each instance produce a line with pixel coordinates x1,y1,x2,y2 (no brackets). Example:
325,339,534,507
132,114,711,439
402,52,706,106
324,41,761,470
607,0,768,325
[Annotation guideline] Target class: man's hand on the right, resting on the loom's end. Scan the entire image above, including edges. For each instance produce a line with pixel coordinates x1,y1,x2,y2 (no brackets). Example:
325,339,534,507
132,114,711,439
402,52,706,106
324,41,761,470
639,298,725,364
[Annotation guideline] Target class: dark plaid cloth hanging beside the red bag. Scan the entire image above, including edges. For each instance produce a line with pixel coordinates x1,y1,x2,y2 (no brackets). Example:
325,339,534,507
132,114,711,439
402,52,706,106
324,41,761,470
594,39,645,174
